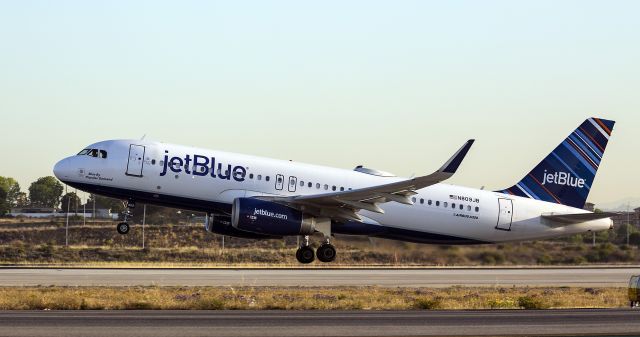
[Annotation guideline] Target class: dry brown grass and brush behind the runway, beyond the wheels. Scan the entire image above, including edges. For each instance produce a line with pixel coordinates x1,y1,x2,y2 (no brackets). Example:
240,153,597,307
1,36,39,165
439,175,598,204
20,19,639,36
0,219,640,268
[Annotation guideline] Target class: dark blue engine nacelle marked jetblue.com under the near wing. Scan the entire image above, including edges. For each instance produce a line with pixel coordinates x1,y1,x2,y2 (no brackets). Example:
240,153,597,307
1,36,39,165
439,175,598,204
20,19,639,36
231,198,316,236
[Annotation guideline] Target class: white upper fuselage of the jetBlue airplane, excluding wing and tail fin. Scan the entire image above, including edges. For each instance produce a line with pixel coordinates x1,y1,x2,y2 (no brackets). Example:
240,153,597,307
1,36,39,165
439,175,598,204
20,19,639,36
54,140,611,243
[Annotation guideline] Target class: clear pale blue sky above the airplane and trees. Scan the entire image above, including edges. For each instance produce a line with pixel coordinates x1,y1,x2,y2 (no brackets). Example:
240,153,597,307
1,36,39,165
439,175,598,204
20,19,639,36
0,0,640,203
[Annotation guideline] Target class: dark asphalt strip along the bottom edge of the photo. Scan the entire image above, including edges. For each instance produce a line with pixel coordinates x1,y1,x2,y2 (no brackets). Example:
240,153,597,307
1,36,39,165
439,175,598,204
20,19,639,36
0,310,640,337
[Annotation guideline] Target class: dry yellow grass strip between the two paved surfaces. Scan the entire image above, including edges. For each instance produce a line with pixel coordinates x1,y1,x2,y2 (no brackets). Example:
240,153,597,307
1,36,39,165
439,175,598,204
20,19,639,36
0,287,627,310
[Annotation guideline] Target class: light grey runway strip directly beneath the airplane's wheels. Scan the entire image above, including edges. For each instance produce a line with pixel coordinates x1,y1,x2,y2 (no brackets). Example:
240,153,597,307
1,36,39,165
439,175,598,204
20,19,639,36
0,267,640,287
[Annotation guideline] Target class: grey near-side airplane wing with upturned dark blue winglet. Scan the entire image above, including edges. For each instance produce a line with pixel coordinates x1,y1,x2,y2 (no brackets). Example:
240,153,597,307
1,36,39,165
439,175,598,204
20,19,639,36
258,139,474,221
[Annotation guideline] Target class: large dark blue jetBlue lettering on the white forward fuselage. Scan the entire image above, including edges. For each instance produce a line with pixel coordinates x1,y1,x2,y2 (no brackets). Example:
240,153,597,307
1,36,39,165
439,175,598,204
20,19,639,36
160,151,247,181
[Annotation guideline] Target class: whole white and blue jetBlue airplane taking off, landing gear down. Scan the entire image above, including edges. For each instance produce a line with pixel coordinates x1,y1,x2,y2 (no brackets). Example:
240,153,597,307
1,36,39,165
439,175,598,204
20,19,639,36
53,118,615,264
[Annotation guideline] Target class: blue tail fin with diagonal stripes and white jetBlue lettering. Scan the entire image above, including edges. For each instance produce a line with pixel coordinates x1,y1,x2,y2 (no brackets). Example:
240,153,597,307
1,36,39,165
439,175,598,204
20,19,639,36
497,118,615,208
